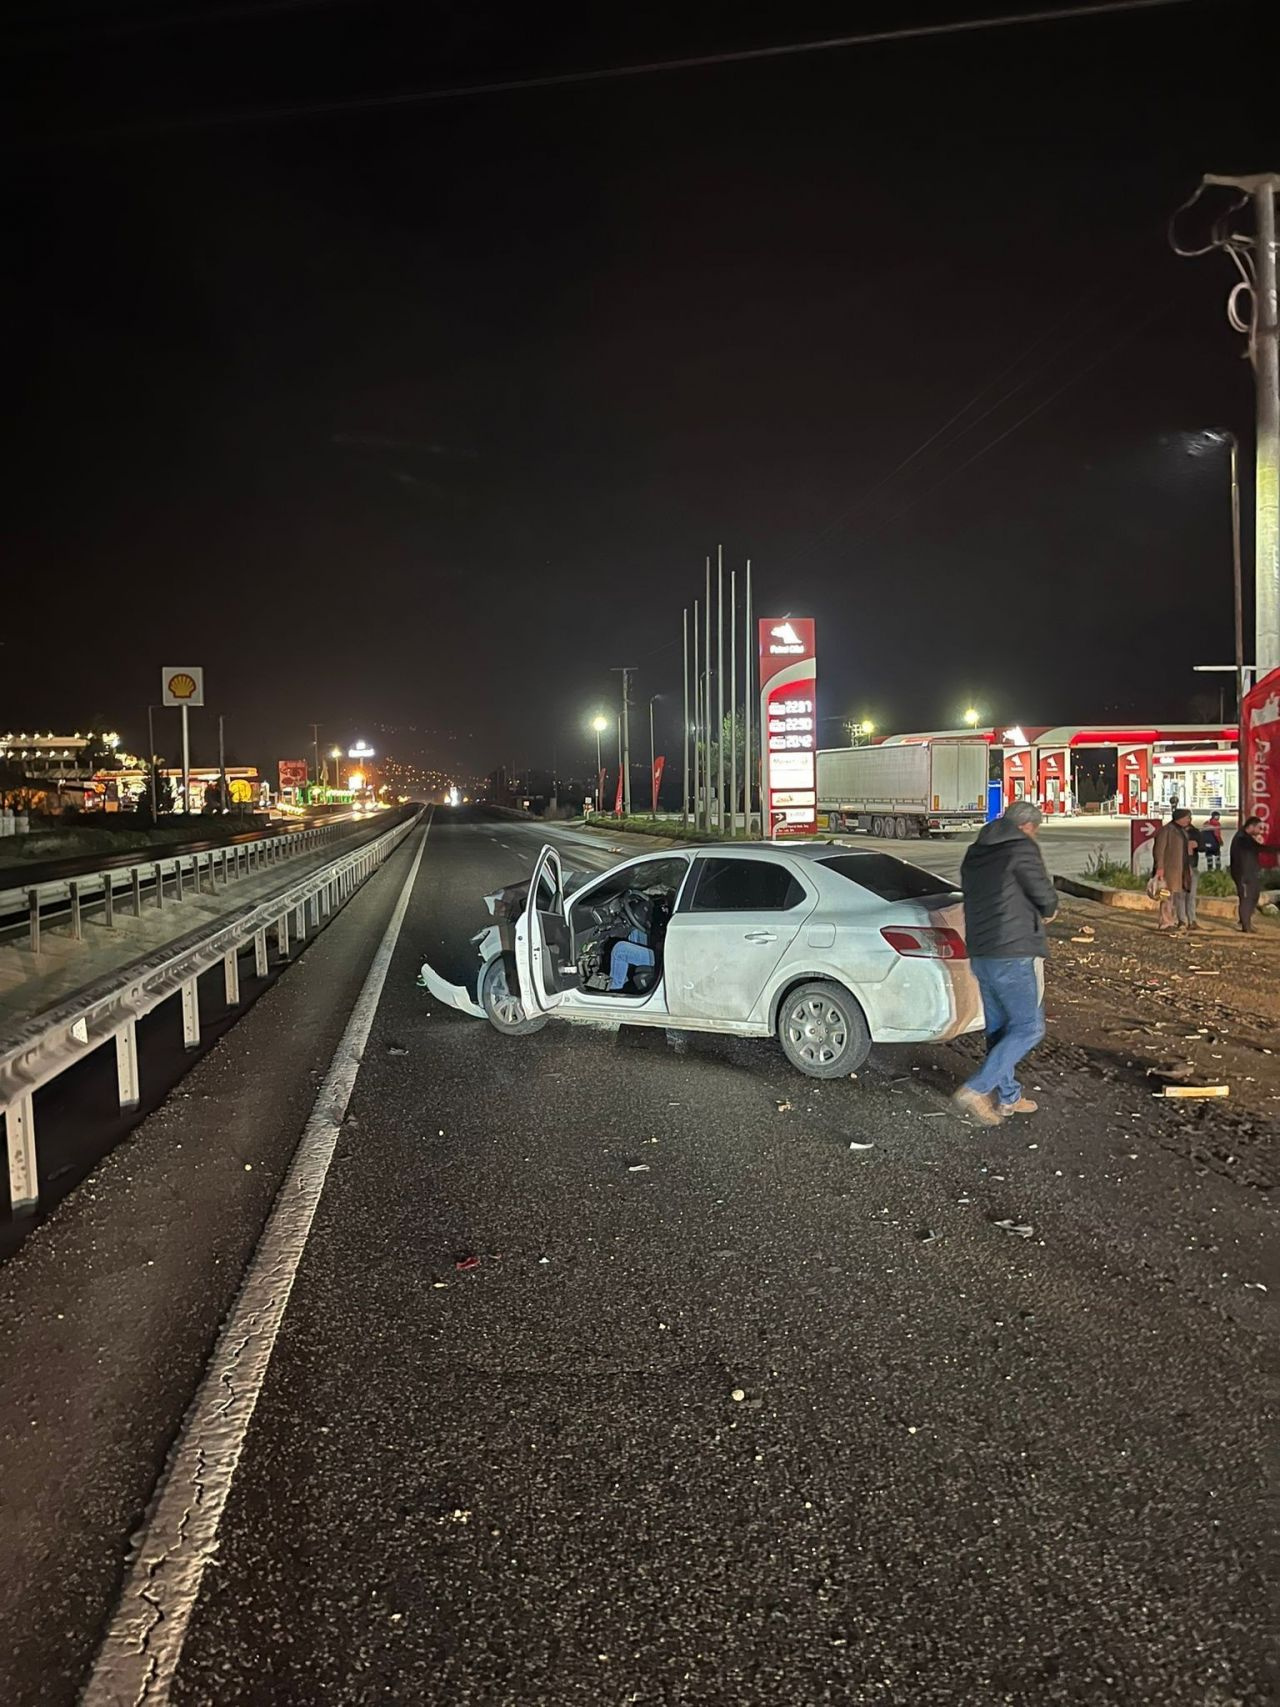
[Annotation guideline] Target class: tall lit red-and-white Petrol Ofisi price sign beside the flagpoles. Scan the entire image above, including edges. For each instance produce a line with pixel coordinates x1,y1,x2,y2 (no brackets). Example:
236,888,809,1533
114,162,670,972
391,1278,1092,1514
759,616,817,836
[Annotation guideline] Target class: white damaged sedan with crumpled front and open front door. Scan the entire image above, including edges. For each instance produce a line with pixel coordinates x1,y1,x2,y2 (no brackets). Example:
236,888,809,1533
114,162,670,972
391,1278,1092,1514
422,842,981,1079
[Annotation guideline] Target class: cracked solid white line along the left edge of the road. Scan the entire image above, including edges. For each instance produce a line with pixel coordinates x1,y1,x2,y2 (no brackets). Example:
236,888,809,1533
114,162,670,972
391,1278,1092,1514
80,816,433,1707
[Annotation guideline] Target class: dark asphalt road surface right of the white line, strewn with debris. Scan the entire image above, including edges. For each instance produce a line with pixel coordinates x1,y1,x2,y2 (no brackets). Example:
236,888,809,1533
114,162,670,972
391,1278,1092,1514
5,816,1277,1707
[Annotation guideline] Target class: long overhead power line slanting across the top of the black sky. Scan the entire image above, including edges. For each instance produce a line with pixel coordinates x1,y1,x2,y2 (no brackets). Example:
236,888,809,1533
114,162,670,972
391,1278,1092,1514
25,0,1200,142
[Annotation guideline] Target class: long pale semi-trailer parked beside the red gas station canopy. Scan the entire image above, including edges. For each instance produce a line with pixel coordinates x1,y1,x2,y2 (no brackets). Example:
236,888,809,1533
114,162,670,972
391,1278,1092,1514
817,741,988,840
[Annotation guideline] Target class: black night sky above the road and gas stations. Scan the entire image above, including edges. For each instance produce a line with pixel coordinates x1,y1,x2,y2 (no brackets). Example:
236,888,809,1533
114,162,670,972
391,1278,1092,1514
0,0,1280,770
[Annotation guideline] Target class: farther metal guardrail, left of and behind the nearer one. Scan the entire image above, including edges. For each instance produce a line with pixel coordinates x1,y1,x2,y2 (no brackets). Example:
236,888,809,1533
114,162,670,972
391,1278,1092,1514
0,821,373,954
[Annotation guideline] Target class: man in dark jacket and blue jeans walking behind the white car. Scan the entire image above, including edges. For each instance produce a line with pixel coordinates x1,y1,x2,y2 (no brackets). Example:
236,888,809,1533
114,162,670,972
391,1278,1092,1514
952,801,1058,1127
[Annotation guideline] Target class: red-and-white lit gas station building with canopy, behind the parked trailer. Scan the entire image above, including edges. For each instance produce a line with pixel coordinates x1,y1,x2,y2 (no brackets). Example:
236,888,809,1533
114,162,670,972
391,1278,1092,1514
881,724,1239,818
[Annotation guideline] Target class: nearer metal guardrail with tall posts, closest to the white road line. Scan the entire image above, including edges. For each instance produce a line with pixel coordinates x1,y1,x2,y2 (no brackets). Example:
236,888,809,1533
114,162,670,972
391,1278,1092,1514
0,813,420,1214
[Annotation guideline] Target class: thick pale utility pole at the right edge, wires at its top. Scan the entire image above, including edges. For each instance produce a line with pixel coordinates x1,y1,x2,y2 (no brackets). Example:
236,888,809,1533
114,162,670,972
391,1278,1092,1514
1253,178,1280,679
